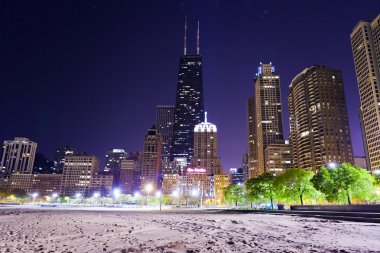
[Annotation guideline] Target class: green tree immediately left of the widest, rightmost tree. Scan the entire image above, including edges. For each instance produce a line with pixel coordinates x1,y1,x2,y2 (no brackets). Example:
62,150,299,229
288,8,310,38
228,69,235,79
274,169,316,205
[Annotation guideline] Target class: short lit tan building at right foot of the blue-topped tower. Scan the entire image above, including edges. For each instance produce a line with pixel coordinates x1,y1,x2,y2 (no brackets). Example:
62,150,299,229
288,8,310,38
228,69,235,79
265,143,294,174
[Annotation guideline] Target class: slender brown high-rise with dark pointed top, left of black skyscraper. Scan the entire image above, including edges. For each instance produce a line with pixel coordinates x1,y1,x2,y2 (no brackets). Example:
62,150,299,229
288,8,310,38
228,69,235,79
141,126,162,190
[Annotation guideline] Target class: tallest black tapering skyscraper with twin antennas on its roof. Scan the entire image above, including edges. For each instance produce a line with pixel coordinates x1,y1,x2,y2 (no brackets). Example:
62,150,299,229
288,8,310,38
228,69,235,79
170,19,204,163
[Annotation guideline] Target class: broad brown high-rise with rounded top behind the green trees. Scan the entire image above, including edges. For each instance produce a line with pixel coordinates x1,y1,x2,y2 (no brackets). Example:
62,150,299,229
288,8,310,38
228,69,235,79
288,66,353,170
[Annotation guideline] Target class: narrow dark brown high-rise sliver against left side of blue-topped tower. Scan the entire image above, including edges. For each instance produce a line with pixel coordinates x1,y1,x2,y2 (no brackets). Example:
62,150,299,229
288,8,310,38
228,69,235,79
246,97,257,179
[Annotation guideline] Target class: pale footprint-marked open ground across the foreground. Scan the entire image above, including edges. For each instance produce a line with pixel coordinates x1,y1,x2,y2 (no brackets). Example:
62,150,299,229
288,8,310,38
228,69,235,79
0,206,380,252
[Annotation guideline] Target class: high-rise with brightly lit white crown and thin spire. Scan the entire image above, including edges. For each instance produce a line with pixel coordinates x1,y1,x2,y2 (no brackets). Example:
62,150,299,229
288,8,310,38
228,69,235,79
191,112,223,176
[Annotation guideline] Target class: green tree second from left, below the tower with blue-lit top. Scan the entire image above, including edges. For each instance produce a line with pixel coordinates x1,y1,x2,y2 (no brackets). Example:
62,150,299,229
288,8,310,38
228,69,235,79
245,173,276,209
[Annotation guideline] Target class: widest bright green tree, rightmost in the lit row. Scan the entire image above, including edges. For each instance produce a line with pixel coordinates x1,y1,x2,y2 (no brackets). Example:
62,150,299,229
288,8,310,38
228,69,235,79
312,163,375,205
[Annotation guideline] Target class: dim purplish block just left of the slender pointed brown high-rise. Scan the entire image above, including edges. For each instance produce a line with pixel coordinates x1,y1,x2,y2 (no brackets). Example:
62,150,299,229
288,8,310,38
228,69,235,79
120,159,138,194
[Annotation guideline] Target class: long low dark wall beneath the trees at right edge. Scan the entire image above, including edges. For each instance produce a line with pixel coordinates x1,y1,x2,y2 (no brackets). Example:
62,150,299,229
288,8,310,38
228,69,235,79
290,205,380,213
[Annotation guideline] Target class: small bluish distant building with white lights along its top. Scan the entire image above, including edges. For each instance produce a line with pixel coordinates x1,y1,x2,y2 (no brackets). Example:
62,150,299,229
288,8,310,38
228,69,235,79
104,148,128,188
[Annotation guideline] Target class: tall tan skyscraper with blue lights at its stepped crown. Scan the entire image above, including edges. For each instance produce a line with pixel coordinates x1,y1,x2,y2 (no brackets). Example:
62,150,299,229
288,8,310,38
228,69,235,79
253,63,284,177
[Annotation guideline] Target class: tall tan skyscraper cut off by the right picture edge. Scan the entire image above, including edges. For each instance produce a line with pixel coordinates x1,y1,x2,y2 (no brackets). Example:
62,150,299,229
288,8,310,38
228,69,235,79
350,14,380,171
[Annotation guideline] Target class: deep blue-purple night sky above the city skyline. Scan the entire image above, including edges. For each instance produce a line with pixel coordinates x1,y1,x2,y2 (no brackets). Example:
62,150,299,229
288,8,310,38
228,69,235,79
0,0,380,168
